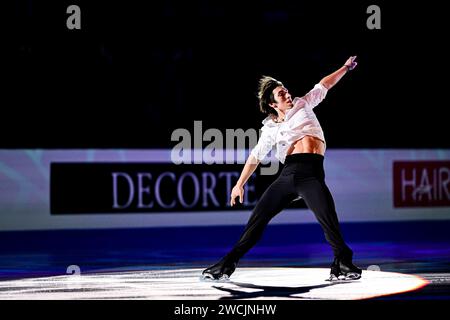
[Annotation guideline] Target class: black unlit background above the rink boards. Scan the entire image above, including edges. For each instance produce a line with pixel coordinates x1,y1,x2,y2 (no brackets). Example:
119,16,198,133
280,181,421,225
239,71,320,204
0,0,450,148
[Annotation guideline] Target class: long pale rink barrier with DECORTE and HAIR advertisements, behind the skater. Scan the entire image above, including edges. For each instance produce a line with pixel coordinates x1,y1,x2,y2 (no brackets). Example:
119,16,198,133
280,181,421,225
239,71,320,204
0,149,450,231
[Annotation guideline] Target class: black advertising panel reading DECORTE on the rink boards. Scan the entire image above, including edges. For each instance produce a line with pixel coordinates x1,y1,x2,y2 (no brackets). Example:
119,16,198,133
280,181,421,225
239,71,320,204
50,162,306,214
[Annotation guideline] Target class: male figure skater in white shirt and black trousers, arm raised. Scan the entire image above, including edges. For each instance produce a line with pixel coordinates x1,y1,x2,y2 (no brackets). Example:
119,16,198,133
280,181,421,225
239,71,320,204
202,56,362,281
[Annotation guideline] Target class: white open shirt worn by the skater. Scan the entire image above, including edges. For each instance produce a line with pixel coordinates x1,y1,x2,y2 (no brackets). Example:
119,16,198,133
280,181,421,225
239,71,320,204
250,83,328,163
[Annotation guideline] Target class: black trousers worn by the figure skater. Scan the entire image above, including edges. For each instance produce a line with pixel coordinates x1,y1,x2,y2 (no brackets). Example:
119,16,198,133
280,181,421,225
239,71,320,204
226,153,353,261
